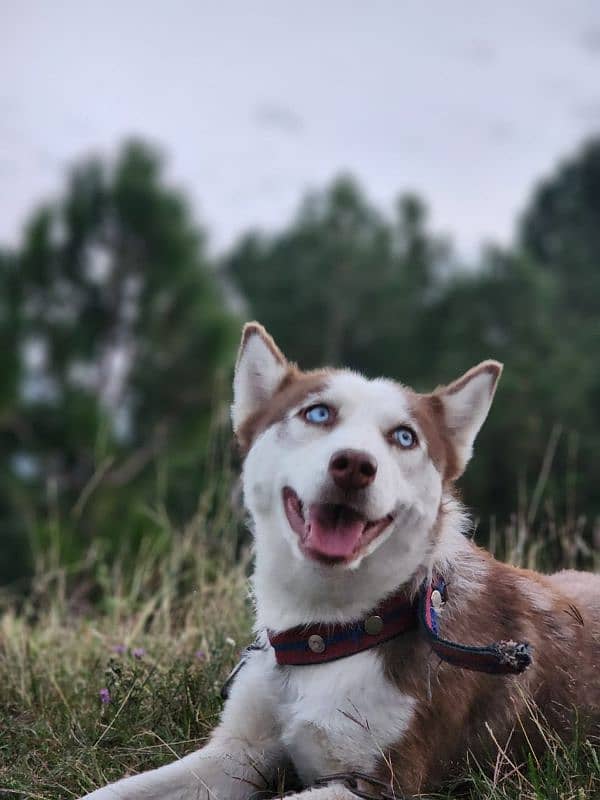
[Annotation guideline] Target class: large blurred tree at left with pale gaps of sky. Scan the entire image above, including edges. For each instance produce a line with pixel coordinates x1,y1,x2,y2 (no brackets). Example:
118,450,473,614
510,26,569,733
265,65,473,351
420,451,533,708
0,142,238,578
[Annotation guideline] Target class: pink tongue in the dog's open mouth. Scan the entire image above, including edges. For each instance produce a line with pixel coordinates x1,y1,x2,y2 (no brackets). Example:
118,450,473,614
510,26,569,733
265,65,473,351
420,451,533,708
305,505,366,558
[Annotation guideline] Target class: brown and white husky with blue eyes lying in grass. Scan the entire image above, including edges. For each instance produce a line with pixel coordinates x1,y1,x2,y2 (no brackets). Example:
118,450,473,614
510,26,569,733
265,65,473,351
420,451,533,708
88,323,600,800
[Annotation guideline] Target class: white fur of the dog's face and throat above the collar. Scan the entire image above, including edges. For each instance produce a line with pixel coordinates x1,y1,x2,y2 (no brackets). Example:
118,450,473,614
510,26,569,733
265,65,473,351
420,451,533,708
243,372,442,630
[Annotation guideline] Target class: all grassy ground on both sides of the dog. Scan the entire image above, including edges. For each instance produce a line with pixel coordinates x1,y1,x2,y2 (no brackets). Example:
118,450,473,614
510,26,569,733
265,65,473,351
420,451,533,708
0,484,600,800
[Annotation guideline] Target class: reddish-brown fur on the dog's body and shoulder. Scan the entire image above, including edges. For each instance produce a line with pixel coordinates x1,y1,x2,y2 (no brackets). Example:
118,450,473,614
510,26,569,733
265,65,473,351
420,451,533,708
379,545,600,793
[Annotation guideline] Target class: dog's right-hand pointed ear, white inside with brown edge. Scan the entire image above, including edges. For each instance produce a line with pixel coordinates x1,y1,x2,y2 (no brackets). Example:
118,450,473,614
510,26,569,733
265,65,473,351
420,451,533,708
435,361,502,480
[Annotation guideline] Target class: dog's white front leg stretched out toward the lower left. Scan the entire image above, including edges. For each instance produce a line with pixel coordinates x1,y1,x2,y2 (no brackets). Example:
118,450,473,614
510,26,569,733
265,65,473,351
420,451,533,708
85,653,284,800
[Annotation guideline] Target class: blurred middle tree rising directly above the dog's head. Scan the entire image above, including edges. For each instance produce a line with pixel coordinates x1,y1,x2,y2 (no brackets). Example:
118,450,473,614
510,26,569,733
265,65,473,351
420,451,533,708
225,178,448,376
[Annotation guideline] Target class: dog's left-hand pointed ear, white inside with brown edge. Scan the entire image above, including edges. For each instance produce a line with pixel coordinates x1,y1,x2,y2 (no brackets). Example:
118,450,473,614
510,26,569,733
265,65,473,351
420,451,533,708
231,322,289,434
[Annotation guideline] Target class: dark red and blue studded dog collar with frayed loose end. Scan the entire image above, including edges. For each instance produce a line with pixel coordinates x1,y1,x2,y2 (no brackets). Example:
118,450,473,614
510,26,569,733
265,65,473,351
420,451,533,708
268,577,531,675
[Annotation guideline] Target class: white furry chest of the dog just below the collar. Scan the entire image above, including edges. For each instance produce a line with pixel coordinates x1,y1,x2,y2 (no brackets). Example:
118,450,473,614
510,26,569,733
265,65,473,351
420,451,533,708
276,651,416,783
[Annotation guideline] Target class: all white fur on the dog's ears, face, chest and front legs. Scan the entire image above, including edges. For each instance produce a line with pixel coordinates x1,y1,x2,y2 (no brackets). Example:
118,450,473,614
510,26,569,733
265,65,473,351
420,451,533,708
83,326,493,800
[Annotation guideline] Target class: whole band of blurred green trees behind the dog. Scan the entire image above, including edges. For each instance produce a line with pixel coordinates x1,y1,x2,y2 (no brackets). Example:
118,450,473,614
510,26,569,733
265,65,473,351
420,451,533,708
0,136,600,581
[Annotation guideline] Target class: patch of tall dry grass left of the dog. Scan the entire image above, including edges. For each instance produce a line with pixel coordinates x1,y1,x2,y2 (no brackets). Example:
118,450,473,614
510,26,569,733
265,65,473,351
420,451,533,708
0,460,251,800
